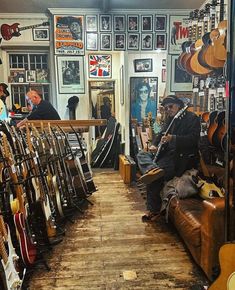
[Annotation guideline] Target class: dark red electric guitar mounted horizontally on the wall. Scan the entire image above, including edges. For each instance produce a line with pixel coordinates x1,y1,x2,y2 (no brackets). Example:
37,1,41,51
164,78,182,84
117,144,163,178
1,22,49,40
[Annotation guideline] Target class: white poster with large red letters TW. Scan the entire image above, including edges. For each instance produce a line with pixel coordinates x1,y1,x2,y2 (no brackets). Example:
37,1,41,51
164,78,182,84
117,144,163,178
168,15,190,54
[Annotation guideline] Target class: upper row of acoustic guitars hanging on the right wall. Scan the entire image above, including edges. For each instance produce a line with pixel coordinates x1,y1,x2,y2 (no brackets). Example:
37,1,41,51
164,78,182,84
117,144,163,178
178,0,227,75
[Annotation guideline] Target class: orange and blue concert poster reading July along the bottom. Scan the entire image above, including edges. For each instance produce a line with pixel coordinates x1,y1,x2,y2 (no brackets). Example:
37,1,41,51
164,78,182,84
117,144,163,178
54,15,85,55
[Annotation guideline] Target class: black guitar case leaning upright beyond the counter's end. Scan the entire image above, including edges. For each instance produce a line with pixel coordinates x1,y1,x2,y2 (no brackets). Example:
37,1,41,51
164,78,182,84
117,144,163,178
91,117,120,167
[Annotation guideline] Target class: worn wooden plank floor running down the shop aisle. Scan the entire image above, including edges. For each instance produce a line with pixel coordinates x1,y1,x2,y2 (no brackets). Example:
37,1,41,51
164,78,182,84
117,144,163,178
29,169,205,290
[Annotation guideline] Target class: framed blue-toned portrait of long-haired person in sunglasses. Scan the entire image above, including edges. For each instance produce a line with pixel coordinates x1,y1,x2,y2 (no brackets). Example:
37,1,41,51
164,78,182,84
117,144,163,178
130,77,158,122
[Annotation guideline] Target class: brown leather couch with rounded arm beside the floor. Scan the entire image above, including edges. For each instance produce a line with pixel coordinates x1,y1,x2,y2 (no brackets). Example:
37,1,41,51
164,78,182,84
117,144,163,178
169,197,229,280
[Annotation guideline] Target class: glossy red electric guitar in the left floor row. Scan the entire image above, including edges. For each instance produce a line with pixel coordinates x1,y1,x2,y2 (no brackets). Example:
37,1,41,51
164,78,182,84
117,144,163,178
14,213,36,266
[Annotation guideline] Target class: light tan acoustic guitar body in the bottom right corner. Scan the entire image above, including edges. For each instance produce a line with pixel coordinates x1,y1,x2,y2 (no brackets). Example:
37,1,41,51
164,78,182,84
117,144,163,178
208,243,235,290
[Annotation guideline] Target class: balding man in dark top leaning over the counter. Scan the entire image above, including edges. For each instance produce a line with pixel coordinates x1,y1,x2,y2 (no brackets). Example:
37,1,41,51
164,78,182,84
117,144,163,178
17,89,60,127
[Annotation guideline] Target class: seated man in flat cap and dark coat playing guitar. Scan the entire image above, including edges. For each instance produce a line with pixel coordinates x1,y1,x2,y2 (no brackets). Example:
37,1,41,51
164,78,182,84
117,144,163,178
137,95,201,222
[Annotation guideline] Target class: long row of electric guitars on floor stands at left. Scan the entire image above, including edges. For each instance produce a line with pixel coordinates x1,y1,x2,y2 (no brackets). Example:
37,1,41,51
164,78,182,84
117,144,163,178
0,122,96,290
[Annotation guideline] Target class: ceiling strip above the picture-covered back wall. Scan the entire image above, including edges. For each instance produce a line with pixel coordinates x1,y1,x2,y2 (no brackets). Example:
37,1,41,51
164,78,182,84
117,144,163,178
0,0,204,13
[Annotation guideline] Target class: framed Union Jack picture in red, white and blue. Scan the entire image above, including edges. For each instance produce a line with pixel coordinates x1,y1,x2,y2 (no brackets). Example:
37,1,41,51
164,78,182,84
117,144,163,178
88,54,112,78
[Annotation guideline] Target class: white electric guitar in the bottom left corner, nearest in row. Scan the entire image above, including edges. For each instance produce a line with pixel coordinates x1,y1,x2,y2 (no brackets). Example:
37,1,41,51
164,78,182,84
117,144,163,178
1,225,22,290
